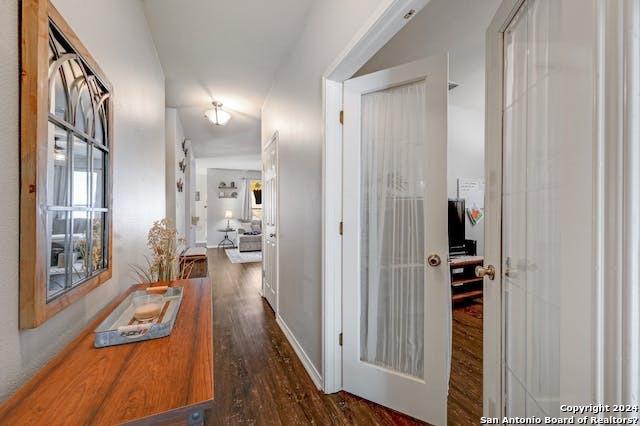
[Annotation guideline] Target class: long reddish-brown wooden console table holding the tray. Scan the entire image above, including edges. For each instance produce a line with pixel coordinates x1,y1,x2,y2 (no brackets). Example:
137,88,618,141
0,278,213,425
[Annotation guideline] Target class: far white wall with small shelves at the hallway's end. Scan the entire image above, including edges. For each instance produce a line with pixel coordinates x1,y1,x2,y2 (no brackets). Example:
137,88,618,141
206,169,262,247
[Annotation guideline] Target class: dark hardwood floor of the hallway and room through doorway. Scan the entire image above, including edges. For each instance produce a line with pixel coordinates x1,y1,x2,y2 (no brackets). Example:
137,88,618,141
208,249,482,425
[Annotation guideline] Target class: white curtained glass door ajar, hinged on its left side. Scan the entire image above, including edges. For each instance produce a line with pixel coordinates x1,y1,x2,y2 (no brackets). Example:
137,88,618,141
343,55,451,425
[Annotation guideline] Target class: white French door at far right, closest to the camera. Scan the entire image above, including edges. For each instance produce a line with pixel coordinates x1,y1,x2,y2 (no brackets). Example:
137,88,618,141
485,0,599,417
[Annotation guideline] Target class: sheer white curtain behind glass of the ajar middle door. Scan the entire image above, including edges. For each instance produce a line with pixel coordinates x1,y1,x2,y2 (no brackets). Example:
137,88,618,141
360,81,426,378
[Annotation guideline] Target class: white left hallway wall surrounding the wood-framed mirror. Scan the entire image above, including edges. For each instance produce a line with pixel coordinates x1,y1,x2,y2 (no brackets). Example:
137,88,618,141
0,0,165,400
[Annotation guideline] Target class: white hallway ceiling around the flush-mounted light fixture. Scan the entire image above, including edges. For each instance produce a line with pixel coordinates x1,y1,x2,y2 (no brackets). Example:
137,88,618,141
144,0,311,158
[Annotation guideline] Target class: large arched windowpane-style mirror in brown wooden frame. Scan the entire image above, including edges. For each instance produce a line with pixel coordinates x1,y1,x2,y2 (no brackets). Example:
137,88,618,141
20,0,113,328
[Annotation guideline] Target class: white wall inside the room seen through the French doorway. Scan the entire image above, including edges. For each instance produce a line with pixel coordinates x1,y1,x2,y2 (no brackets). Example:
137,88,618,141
357,0,501,254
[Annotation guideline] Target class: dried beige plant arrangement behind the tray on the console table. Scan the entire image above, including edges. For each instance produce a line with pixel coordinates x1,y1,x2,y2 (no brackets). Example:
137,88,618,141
131,218,190,283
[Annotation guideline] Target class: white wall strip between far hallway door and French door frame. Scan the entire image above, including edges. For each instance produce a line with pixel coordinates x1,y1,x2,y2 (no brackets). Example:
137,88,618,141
262,0,390,371
